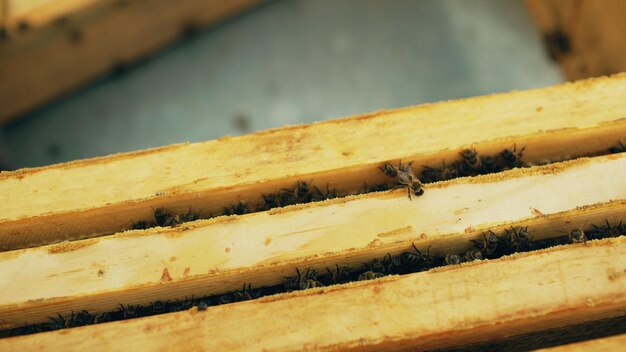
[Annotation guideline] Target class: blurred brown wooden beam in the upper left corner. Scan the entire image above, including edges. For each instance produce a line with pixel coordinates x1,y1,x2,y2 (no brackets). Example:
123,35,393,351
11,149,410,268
0,0,262,122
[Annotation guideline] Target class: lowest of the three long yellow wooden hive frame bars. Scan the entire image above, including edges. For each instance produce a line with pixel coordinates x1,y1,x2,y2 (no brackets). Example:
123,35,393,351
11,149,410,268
0,237,626,351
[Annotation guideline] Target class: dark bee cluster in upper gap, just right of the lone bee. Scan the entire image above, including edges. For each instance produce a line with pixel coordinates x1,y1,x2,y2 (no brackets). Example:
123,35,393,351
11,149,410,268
420,146,526,183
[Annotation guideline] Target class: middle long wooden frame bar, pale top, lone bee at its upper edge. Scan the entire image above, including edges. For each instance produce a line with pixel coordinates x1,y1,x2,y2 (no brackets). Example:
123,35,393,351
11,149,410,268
0,153,626,327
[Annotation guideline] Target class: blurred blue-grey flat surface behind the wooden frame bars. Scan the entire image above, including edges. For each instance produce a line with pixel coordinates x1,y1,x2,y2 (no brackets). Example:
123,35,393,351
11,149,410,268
4,0,563,167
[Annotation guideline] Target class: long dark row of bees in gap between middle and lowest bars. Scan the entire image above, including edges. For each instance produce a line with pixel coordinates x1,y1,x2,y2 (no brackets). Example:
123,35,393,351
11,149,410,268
7,220,626,336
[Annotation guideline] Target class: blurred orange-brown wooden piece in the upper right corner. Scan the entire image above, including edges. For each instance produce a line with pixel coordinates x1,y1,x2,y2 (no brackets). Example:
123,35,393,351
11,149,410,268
526,0,626,81
